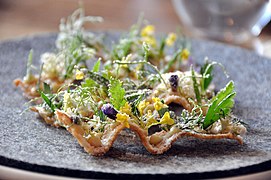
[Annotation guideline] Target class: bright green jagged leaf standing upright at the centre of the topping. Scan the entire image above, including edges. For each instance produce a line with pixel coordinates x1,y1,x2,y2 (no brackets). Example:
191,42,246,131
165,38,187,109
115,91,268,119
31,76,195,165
108,78,126,110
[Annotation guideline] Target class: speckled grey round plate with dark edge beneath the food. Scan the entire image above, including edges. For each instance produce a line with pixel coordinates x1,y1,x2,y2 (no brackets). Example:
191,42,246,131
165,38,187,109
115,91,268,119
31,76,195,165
0,33,271,179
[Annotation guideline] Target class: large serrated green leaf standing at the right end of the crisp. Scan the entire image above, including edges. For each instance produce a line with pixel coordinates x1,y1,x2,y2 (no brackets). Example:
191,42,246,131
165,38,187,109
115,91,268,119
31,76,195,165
203,81,236,129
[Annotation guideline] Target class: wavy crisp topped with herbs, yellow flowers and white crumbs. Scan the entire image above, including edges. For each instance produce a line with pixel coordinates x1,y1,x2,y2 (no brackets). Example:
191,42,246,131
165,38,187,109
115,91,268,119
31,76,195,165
14,8,246,156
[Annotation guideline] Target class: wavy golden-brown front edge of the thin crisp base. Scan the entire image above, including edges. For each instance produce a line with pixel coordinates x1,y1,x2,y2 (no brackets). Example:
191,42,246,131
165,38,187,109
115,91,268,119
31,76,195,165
36,110,243,156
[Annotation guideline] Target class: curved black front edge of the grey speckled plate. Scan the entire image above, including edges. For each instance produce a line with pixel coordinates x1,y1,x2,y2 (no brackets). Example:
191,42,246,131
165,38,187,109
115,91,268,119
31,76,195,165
0,155,271,179
